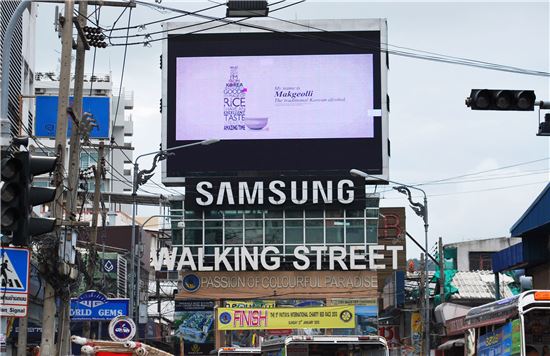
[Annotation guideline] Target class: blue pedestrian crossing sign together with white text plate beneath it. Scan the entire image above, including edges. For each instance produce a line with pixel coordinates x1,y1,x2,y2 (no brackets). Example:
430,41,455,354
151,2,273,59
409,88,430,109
0,247,30,318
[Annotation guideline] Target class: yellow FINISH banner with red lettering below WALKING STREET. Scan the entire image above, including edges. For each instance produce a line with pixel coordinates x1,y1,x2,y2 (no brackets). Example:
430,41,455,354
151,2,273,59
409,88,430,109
217,305,355,330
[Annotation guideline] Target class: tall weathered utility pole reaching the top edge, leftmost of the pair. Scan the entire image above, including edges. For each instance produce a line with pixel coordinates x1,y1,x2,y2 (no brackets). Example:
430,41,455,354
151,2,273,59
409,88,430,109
40,0,74,355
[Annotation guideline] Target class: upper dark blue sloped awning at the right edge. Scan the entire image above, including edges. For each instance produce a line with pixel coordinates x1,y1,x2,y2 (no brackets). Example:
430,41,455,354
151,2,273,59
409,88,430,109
510,183,550,237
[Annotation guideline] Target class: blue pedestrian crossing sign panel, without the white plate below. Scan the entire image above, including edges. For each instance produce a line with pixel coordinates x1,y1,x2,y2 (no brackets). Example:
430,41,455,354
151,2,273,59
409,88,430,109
0,247,30,293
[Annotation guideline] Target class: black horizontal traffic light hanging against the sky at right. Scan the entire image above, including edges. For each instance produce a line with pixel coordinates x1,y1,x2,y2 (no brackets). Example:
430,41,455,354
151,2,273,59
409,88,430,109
466,89,536,111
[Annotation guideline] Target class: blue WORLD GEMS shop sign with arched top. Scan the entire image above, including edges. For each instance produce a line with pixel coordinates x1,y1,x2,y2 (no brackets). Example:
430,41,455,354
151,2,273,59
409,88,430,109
71,290,130,321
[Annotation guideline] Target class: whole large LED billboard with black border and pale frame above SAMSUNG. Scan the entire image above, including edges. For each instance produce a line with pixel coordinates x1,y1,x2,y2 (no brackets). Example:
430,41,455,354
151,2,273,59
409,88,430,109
163,20,388,184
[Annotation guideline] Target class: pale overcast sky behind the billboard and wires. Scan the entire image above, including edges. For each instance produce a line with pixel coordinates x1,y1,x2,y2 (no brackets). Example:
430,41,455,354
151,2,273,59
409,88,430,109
36,0,550,257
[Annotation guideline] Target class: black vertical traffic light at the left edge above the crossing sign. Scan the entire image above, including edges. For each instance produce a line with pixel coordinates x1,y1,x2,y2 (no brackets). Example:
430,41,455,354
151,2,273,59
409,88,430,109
2,152,57,246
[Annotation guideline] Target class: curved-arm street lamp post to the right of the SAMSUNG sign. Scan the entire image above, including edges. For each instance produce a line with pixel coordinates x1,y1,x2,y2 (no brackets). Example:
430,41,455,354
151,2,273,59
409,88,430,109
350,169,430,355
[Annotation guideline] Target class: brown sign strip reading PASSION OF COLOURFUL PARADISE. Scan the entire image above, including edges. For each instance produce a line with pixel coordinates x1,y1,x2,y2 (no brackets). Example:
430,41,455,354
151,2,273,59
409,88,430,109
176,271,377,299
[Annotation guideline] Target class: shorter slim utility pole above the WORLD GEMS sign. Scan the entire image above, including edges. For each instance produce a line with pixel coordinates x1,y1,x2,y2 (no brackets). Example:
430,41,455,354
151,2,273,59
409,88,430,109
83,141,105,338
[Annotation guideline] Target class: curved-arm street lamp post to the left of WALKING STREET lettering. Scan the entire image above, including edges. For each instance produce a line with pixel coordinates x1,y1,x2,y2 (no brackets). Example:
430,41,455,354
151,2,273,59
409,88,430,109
129,139,220,324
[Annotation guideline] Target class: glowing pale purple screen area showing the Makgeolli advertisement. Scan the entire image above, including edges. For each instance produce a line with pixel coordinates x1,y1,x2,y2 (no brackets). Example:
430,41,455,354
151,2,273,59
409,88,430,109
176,54,374,141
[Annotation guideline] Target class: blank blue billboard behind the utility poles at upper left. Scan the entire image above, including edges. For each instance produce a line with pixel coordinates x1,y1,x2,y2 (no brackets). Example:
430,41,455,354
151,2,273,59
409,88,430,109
34,95,111,138
